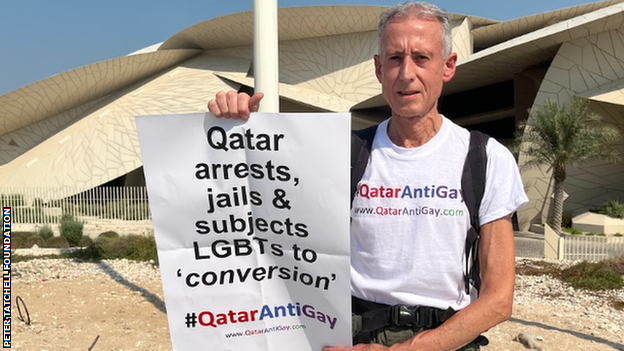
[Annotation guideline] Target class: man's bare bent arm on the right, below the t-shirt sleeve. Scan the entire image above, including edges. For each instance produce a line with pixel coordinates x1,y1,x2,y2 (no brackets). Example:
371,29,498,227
324,214,515,351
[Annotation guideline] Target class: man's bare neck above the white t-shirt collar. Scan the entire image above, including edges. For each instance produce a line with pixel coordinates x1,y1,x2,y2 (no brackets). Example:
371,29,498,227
388,111,442,147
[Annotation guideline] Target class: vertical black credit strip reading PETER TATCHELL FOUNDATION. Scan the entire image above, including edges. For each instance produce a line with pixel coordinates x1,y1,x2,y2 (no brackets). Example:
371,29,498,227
2,207,11,349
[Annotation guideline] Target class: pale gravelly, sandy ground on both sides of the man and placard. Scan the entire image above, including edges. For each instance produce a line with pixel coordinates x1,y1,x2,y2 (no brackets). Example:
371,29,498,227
13,258,624,351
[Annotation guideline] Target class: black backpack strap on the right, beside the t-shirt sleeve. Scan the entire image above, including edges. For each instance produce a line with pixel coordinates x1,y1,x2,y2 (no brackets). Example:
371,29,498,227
461,130,489,294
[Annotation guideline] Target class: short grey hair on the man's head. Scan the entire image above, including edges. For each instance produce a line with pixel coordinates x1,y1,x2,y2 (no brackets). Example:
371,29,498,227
377,1,453,57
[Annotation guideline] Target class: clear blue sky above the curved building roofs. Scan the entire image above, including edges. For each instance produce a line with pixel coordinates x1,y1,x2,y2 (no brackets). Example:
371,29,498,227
0,0,604,95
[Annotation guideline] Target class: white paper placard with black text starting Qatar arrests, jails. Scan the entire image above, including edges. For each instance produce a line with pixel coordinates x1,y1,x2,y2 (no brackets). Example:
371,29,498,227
136,113,351,351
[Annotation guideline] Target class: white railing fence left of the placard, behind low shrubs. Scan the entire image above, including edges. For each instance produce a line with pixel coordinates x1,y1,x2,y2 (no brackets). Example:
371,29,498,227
0,187,151,224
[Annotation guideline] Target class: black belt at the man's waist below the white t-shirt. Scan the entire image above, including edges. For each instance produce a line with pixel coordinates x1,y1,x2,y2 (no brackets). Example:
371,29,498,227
351,297,455,333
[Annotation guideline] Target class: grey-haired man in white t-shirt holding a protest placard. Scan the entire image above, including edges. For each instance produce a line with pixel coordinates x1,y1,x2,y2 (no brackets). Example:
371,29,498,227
208,2,527,351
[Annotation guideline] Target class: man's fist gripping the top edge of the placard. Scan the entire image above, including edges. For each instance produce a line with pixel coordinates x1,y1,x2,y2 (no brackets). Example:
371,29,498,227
208,90,264,121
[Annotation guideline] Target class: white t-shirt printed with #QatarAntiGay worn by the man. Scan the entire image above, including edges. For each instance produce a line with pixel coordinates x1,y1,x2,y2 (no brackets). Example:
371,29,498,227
351,117,528,309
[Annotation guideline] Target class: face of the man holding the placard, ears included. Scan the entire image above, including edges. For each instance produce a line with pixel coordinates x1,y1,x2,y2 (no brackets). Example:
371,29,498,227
375,16,457,118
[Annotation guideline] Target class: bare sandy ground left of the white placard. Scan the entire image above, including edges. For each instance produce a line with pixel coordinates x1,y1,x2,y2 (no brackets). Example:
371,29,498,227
13,277,171,351
